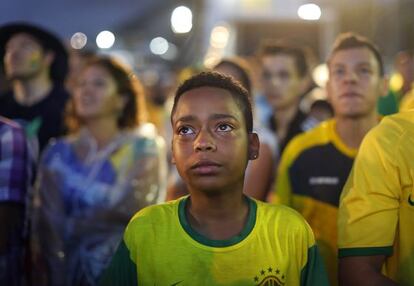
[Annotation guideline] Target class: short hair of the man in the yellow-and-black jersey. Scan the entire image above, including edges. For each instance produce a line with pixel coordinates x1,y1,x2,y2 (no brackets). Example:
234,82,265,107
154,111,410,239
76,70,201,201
327,32,384,76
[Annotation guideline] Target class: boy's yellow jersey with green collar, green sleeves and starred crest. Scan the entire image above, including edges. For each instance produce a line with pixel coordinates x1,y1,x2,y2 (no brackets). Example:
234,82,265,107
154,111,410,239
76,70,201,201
101,197,328,286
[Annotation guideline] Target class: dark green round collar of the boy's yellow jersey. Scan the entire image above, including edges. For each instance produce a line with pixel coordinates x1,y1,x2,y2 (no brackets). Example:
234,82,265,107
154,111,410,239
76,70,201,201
178,196,257,247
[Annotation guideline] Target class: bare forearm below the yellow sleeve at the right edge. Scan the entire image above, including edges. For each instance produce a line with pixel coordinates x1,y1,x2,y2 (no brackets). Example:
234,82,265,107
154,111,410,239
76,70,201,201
339,255,398,286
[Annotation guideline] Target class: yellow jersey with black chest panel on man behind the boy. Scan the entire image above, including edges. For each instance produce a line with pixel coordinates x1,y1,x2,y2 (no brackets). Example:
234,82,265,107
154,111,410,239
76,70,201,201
273,119,357,285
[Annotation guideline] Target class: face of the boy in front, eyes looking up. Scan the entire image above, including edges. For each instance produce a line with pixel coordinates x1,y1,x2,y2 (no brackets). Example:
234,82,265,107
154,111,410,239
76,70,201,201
172,87,259,193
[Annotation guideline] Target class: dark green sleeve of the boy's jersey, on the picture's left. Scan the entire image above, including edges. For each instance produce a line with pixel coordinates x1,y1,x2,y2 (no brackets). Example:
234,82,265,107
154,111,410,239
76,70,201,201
99,240,138,286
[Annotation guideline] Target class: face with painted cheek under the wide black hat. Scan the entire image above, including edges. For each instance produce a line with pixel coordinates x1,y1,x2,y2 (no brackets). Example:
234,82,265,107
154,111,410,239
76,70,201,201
4,33,51,80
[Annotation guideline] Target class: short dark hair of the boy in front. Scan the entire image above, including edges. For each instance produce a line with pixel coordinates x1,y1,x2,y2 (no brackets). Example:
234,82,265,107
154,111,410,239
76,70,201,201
171,71,253,133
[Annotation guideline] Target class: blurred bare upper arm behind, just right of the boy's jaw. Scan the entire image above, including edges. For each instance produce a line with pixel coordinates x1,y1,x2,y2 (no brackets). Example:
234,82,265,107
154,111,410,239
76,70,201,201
244,144,274,201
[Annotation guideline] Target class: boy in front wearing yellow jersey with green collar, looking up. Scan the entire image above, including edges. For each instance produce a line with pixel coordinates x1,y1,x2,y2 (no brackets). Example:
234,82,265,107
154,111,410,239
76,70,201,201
101,72,328,286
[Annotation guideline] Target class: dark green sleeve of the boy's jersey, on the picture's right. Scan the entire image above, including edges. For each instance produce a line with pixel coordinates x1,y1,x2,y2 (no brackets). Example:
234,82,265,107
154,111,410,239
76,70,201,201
300,245,329,286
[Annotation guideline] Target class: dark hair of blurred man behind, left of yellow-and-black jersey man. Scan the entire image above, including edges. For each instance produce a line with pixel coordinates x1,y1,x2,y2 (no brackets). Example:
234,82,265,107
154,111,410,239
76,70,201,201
259,40,308,78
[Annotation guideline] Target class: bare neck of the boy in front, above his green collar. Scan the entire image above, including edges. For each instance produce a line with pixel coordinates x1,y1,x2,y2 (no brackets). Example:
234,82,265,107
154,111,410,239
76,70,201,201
186,191,249,240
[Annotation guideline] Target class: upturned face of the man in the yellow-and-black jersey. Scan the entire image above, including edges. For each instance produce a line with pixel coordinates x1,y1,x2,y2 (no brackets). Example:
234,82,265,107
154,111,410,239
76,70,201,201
327,47,386,118
